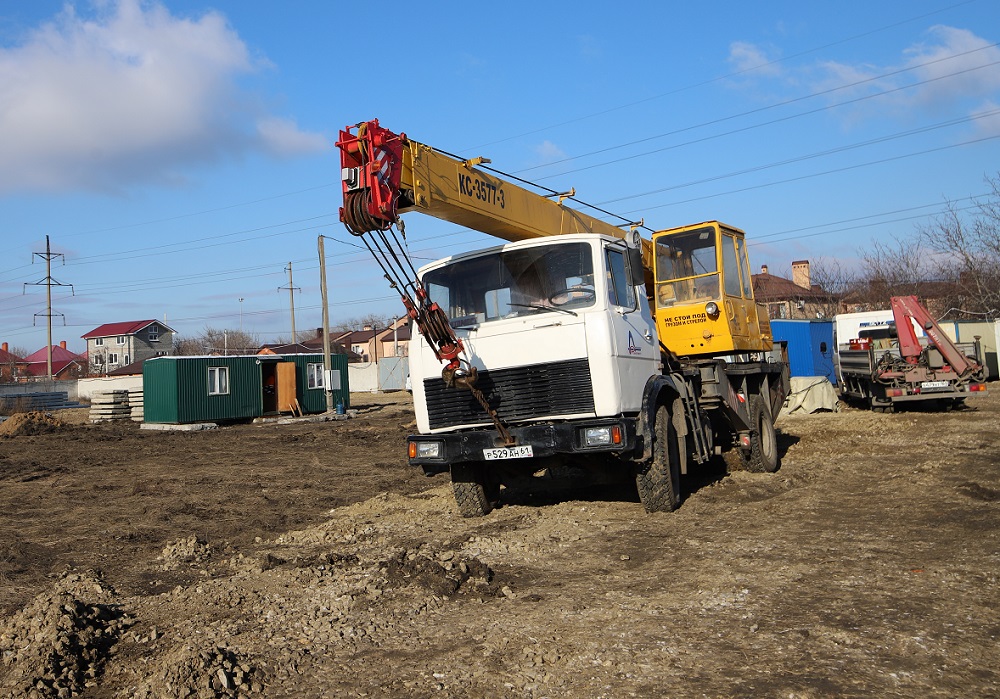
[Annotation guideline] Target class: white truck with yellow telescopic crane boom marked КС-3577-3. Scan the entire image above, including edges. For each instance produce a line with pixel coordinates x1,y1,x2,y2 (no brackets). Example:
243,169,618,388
337,120,788,517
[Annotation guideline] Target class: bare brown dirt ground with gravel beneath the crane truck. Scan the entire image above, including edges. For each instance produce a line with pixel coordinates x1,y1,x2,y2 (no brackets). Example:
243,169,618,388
0,386,1000,699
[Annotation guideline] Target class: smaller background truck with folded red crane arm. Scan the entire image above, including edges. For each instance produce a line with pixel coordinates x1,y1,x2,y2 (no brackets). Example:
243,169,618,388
834,296,986,412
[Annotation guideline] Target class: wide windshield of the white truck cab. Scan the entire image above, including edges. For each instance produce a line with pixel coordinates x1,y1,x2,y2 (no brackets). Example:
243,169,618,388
423,243,597,327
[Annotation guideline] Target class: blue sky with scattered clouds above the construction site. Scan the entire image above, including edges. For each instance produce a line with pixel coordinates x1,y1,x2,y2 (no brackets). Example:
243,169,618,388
0,0,1000,351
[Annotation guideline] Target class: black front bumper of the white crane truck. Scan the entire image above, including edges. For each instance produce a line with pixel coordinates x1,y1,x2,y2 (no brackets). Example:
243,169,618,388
407,417,642,475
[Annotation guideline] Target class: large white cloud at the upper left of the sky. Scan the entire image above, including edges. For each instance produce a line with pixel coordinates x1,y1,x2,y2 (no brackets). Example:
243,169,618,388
0,0,327,193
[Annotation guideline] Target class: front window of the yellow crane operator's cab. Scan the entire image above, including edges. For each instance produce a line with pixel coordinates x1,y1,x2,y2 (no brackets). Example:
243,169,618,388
656,227,720,306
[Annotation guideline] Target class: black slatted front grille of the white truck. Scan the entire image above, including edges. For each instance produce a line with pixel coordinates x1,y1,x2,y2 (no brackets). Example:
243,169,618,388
424,358,594,429
